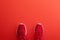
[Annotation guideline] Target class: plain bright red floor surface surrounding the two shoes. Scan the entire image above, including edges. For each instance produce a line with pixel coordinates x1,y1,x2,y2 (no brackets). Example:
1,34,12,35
0,0,60,40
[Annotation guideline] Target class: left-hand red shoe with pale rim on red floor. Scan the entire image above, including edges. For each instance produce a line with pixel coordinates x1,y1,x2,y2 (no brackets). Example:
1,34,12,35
17,23,27,40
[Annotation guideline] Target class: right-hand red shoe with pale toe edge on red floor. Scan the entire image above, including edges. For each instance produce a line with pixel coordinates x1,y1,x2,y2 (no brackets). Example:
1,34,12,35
34,23,43,40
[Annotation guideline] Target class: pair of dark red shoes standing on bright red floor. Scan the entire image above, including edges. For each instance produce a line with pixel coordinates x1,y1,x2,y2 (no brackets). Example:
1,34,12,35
17,23,43,40
